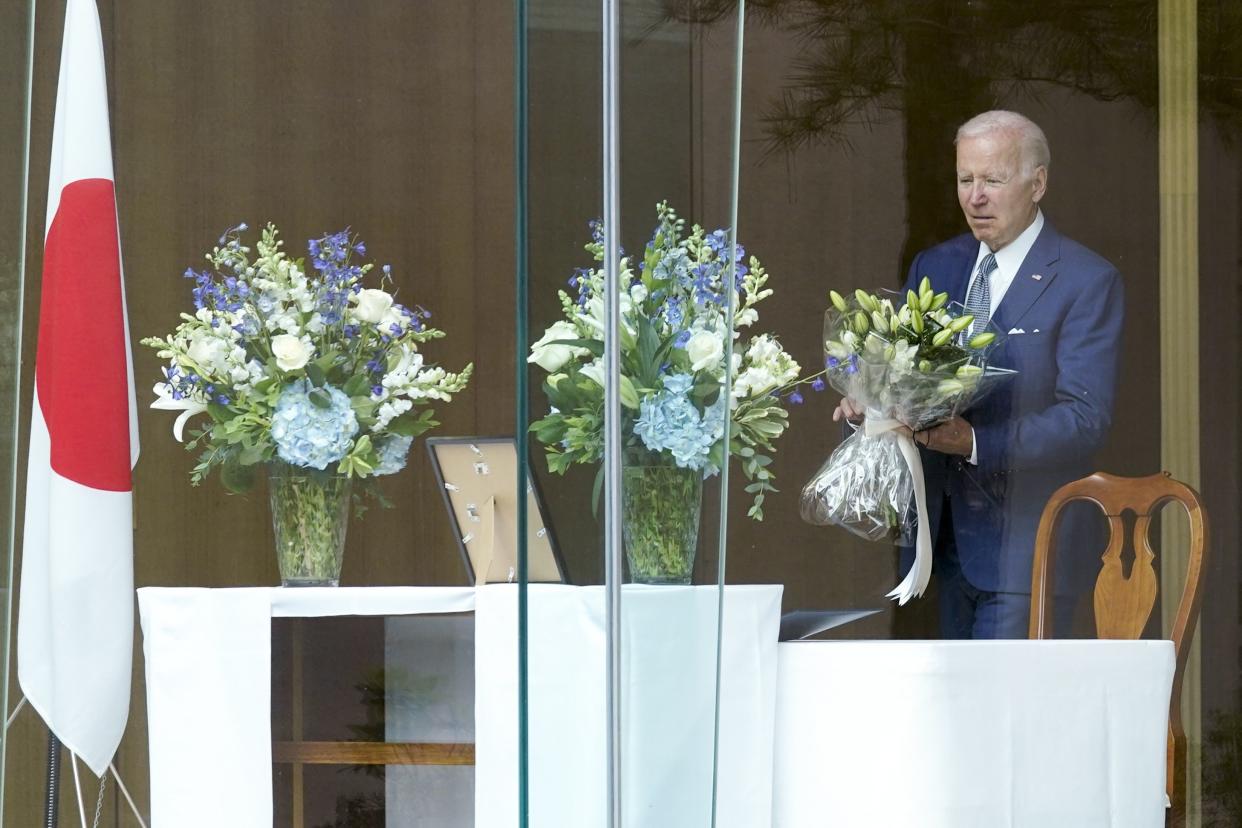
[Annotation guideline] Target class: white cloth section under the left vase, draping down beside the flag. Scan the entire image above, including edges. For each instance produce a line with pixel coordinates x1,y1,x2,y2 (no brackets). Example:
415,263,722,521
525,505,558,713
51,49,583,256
138,587,474,828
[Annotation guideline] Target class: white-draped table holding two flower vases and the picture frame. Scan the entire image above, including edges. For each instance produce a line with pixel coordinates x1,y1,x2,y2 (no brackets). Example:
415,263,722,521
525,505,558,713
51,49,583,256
138,585,781,828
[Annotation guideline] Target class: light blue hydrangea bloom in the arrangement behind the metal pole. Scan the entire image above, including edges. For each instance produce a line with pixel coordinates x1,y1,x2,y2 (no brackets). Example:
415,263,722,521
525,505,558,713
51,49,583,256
633,374,724,474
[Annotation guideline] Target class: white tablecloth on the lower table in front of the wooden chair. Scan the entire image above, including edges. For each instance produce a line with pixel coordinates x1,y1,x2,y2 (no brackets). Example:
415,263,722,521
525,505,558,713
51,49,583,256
773,641,1174,828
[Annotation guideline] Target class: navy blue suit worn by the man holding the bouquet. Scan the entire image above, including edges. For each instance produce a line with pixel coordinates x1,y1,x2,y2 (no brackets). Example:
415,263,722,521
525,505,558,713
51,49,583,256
903,221,1124,595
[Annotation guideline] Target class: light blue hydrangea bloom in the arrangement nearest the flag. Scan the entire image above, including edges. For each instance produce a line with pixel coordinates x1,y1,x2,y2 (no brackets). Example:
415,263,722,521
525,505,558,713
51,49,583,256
272,380,358,469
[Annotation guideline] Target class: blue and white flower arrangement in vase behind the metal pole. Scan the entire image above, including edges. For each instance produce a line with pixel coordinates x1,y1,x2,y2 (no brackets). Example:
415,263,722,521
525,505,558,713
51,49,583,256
528,202,822,582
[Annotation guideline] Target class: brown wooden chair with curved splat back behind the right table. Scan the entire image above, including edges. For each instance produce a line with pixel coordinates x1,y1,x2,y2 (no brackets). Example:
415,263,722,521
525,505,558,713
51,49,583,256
1030,472,1208,824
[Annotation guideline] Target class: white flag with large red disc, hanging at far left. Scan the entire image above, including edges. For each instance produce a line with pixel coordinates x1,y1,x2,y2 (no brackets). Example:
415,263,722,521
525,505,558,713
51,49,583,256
17,0,138,775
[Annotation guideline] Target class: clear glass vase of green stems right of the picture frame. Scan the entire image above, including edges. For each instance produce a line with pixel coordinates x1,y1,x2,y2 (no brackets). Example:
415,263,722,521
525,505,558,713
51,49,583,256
621,466,703,583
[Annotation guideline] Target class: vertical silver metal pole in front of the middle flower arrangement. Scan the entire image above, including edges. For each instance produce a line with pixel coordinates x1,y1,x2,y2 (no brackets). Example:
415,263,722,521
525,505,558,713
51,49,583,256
602,0,621,828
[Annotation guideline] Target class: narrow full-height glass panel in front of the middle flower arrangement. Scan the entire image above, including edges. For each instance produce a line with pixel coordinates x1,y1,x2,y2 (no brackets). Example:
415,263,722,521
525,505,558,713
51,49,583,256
519,0,737,824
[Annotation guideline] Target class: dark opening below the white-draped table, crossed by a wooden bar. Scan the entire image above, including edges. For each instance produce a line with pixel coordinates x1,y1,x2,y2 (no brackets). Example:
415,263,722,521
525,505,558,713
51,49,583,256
272,613,474,828
